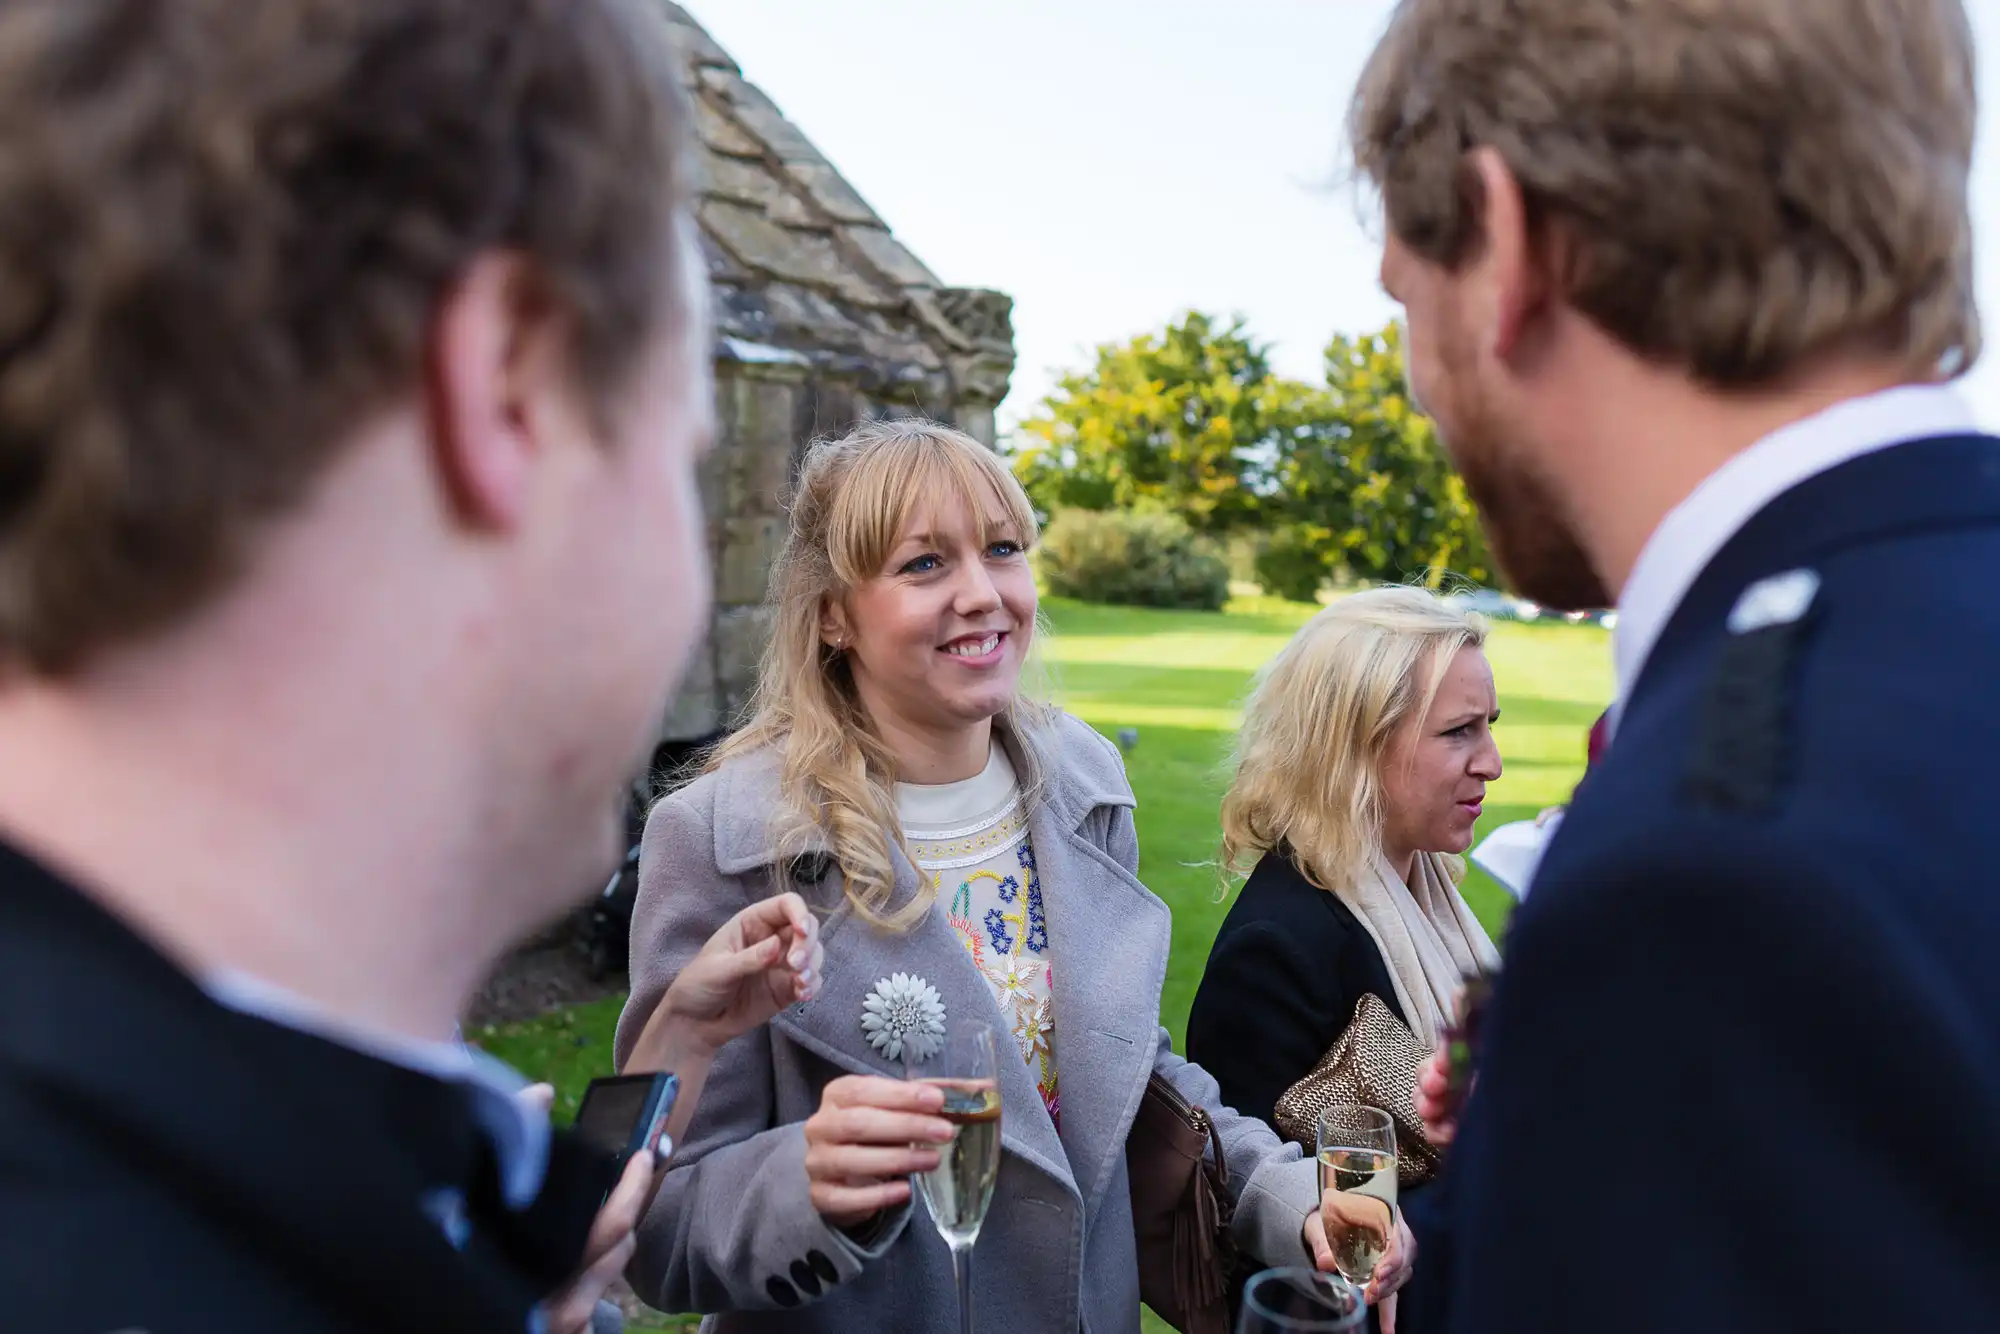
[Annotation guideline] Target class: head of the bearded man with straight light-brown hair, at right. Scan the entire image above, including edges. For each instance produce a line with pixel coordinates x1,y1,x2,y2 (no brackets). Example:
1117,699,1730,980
1350,0,1980,608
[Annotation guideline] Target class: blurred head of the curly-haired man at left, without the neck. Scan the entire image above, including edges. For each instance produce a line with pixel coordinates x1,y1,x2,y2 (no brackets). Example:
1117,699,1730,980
0,0,710,972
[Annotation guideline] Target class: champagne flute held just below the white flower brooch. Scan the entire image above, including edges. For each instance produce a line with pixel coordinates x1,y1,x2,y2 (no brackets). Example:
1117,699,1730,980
904,1020,1000,1334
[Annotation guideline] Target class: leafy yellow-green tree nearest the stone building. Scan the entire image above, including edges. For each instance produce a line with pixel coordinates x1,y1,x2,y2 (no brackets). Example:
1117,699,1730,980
1014,312,1304,534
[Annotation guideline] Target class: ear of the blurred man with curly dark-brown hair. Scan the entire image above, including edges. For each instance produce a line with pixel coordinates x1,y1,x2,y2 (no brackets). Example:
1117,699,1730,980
424,252,566,530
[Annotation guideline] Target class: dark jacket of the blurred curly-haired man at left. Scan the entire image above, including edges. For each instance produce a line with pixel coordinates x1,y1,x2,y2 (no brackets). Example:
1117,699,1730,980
0,846,614,1334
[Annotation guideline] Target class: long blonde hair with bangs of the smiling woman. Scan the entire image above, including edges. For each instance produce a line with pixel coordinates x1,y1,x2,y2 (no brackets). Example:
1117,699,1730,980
708,418,1050,930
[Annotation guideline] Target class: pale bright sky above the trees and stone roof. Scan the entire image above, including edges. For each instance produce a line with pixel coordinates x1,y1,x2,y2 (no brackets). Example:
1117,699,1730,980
684,0,2000,426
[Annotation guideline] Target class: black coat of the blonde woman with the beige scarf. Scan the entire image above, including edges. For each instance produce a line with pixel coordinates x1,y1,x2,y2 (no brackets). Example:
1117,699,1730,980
1188,852,1404,1154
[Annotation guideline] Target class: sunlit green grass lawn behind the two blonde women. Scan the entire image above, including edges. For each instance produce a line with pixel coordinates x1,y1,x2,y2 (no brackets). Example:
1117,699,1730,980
474,598,1612,1330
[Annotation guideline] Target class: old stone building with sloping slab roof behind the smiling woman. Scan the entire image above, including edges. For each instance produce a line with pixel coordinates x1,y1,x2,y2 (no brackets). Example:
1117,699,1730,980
662,0,1014,744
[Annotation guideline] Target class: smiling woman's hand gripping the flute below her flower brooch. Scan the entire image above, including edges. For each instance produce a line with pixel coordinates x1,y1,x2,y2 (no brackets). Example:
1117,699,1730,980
806,1076,952,1228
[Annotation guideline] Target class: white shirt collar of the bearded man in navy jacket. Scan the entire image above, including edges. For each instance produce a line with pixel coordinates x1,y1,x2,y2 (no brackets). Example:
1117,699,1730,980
1606,384,1978,732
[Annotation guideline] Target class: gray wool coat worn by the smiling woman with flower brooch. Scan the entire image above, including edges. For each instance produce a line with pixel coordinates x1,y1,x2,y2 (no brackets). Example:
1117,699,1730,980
618,716,1318,1334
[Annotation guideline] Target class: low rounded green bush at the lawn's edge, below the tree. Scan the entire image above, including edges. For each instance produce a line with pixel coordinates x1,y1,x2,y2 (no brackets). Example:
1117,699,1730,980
1038,510,1230,612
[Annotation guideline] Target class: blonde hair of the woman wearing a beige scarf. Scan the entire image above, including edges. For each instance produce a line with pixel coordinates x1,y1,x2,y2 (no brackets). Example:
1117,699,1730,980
1222,588,1486,892
